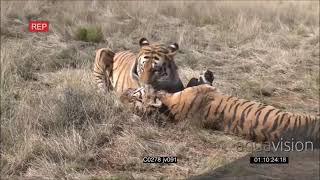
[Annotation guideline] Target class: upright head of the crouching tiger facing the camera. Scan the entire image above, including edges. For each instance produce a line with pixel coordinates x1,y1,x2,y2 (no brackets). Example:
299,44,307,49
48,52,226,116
136,38,183,92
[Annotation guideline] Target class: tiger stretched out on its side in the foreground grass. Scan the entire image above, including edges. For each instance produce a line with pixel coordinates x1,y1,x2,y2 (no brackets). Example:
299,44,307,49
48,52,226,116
122,59,320,146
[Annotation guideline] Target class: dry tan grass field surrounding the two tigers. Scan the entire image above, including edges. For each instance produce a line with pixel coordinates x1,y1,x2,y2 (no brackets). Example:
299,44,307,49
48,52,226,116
1,0,320,179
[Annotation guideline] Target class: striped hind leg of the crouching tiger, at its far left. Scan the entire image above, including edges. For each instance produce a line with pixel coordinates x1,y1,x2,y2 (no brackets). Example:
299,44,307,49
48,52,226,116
93,48,115,92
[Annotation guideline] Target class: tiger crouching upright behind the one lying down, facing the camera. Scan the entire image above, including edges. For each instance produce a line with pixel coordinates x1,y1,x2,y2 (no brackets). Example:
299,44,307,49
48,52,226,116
93,38,184,95
